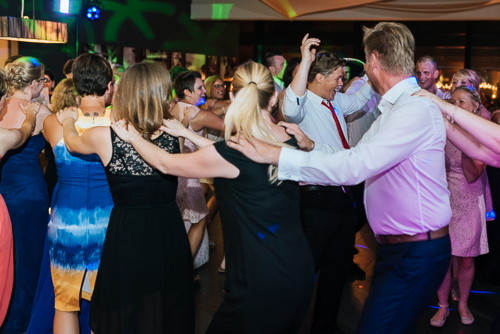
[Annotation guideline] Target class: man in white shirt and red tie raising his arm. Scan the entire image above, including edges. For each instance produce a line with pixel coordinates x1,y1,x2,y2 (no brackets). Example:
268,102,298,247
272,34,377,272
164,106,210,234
282,35,375,334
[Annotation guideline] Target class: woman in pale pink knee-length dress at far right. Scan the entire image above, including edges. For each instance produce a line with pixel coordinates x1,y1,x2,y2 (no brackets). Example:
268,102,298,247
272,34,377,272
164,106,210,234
430,86,491,327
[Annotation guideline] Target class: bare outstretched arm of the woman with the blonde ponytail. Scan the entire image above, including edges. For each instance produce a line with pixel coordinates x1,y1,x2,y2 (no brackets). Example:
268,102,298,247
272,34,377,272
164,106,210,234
111,120,239,179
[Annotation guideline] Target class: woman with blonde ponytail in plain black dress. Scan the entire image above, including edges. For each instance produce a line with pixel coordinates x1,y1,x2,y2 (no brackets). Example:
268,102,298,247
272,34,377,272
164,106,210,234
107,62,314,333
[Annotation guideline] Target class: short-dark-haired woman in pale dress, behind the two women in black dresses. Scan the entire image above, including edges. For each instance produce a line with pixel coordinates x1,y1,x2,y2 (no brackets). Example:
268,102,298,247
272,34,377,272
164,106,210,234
170,72,224,270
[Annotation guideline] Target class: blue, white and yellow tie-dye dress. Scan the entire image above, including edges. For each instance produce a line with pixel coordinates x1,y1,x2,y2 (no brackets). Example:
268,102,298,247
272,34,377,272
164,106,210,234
47,140,113,312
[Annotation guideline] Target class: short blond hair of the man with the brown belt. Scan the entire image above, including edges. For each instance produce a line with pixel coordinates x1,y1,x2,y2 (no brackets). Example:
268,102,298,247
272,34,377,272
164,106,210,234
363,22,415,76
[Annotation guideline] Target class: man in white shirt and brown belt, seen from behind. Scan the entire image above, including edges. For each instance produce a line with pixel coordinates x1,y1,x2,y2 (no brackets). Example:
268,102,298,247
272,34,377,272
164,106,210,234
228,22,451,334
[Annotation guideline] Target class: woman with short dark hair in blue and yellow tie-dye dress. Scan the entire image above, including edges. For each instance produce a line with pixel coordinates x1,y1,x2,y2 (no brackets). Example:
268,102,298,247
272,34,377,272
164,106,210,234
39,53,115,334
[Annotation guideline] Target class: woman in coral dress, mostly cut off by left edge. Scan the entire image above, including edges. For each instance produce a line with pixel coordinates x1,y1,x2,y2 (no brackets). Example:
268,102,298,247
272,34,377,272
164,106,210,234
0,69,40,327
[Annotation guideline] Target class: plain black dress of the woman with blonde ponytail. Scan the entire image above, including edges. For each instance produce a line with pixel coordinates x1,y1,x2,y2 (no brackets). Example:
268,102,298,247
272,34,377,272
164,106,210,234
207,139,314,334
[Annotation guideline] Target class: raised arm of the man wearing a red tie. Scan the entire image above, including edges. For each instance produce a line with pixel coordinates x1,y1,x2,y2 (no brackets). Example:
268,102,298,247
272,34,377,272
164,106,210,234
281,34,321,124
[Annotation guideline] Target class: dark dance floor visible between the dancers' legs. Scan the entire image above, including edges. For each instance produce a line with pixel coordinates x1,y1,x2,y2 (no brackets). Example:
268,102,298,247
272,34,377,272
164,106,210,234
196,216,500,334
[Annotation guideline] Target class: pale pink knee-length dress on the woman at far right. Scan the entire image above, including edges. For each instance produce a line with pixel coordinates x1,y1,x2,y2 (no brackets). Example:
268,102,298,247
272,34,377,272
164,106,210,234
445,141,491,257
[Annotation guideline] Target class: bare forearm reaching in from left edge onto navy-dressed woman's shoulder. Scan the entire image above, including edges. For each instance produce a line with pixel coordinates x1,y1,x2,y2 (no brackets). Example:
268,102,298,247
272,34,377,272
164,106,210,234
0,102,40,157
